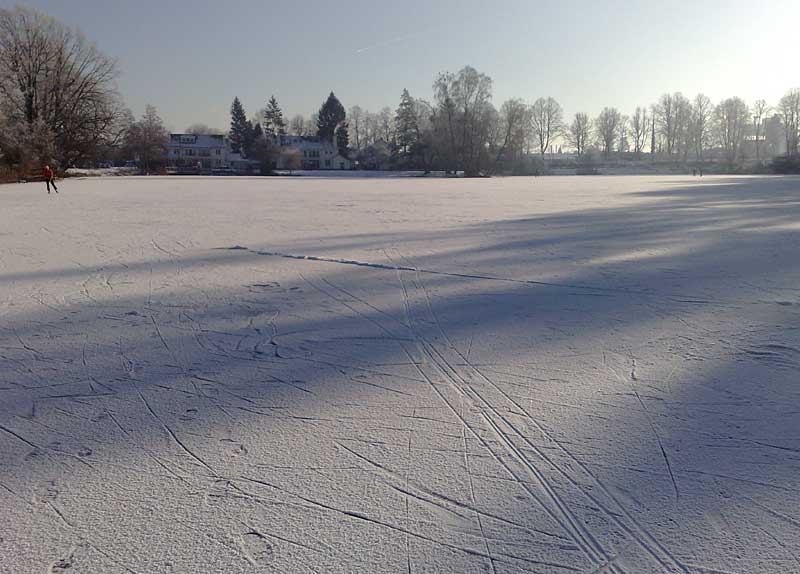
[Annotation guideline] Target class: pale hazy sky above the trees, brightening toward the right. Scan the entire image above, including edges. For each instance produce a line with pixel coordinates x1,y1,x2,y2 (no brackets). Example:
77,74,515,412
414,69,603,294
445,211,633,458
9,0,800,130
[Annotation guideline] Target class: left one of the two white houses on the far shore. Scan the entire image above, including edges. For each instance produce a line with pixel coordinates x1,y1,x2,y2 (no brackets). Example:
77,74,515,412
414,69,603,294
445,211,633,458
167,134,259,173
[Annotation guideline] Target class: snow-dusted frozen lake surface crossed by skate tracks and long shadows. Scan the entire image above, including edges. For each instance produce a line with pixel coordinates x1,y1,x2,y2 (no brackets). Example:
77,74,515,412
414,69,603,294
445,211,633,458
0,176,800,574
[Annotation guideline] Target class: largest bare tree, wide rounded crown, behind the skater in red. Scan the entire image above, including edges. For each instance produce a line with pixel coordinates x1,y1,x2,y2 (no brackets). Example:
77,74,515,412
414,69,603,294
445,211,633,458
0,6,124,168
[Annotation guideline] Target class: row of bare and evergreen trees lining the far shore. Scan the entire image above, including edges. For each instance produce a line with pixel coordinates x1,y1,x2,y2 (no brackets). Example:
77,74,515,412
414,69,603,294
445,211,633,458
0,6,800,176
